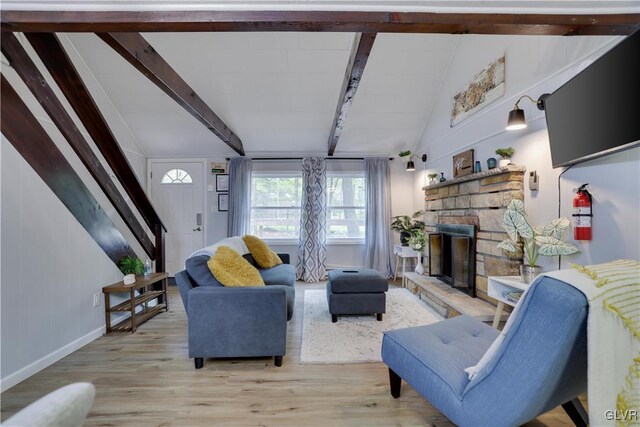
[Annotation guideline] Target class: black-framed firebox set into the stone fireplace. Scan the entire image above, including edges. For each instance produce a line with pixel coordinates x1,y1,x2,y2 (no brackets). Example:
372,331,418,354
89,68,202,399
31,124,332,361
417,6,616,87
429,224,476,297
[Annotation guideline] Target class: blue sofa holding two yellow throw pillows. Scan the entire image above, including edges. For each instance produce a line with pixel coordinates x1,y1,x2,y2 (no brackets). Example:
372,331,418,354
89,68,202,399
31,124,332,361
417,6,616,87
175,254,296,369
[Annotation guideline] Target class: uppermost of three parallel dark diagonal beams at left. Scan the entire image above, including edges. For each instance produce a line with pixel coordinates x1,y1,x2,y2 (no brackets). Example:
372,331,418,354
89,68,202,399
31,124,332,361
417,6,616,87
25,33,166,234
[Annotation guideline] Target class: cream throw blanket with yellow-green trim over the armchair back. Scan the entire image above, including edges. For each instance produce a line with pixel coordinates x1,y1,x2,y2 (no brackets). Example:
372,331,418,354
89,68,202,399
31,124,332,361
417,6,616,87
545,260,640,426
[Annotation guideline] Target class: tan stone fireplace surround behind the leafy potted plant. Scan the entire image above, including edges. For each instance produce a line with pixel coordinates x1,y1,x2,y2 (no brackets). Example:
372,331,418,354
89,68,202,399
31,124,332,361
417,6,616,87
423,165,525,304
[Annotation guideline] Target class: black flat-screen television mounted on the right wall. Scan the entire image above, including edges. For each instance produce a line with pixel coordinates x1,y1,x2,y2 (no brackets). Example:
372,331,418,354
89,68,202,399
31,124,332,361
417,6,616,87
545,31,640,168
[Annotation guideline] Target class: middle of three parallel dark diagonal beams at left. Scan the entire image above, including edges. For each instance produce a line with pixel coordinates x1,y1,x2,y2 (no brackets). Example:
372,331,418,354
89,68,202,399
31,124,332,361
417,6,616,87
0,33,155,259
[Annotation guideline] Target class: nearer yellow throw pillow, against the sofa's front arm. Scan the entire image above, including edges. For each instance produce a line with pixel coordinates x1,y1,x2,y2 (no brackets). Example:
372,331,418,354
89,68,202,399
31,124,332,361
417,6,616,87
207,246,264,287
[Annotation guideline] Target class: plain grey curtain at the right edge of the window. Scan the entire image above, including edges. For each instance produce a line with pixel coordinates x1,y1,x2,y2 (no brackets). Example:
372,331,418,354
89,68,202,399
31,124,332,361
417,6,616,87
364,158,394,277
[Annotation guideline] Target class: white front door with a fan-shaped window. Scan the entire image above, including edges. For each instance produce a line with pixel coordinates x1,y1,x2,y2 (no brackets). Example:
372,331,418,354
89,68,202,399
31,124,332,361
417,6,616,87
150,160,205,276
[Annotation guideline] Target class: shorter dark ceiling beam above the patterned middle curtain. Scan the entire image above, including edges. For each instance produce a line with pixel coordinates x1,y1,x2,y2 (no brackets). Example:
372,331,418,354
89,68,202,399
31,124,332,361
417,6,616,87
329,33,376,156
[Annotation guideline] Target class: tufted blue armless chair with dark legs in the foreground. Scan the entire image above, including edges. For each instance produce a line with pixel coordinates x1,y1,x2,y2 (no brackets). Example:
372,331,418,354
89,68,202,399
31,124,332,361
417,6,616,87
382,277,588,427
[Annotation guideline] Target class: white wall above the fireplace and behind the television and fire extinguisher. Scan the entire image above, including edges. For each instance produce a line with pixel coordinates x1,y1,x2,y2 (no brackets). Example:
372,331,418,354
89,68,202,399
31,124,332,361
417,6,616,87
414,36,640,270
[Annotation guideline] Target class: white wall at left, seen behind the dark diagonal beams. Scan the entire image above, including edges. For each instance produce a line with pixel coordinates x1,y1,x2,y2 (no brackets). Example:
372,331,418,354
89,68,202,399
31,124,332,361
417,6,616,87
0,37,146,391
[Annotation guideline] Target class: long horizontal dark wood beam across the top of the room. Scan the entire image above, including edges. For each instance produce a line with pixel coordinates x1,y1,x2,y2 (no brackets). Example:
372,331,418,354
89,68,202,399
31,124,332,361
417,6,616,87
0,10,640,36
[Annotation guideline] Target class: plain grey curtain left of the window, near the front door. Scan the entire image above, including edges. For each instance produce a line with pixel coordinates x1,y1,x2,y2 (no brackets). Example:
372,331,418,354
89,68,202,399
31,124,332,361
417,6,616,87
227,157,252,237
